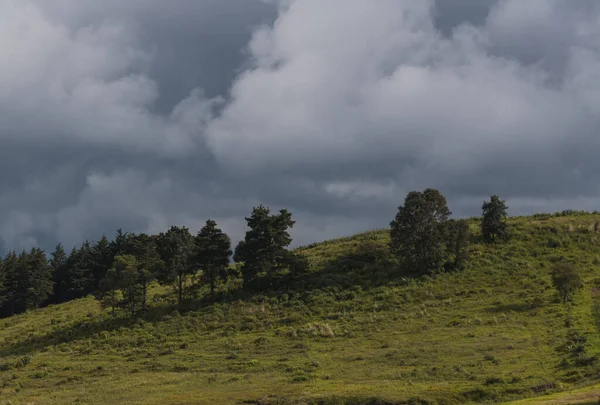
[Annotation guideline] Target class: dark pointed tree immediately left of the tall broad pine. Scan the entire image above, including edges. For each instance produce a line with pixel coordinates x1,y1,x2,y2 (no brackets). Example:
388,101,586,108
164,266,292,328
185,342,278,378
194,219,232,295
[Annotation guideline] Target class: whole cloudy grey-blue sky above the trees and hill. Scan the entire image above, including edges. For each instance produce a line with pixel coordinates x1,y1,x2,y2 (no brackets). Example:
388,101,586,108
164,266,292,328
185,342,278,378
0,0,600,249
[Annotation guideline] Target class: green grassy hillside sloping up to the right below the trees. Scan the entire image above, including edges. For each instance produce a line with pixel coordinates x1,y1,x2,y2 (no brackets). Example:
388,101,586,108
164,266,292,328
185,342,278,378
0,214,600,405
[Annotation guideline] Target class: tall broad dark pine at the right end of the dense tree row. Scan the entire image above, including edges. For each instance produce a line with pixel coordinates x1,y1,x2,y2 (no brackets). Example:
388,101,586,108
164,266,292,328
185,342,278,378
235,205,295,290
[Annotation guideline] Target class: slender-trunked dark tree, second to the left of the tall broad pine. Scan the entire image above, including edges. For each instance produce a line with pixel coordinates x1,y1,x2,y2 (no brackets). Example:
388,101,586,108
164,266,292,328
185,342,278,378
157,226,196,309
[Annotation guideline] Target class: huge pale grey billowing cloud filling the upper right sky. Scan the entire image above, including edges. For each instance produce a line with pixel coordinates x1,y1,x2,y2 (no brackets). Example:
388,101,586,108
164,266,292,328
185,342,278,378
208,1,598,202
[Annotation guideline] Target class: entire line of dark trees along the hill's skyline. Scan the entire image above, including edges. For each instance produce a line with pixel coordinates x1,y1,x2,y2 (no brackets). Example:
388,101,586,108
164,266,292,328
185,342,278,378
0,189,540,317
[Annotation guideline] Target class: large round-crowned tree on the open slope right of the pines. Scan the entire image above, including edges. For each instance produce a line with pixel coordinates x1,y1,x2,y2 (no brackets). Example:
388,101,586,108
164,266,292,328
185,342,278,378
390,188,451,274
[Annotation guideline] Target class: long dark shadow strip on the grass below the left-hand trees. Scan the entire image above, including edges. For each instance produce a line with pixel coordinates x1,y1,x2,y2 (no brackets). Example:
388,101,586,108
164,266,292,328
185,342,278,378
0,305,176,357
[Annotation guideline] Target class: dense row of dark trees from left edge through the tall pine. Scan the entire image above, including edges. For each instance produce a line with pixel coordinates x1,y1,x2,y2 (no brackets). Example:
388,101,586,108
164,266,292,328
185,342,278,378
0,206,307,316
